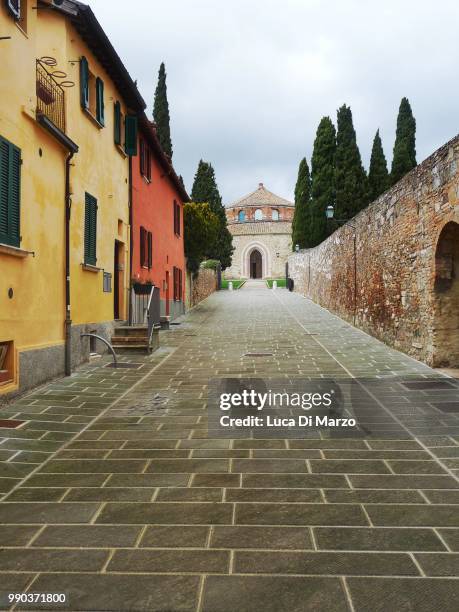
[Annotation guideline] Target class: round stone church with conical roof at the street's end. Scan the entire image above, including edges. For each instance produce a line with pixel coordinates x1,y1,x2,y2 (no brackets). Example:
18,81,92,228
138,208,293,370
225,183,294,279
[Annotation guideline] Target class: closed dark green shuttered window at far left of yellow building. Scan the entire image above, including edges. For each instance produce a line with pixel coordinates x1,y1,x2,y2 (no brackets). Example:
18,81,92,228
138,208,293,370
0,136,21,247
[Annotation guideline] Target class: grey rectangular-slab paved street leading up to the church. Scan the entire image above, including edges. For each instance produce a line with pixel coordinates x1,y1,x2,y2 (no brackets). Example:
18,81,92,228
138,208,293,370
0,284,459,612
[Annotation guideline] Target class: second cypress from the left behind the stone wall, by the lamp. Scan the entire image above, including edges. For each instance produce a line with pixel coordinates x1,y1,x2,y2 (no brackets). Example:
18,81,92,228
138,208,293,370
306,117,336,247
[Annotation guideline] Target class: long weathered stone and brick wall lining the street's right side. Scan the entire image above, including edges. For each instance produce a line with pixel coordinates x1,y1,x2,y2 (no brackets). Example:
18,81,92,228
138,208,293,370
289,136,459,367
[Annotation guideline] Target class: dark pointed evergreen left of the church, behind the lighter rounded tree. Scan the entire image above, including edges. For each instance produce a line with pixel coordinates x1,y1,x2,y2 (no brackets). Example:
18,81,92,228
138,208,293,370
191,159,234,270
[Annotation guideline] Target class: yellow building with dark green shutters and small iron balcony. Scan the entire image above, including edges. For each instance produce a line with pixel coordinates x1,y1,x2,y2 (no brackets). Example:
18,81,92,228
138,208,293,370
0,0,145,394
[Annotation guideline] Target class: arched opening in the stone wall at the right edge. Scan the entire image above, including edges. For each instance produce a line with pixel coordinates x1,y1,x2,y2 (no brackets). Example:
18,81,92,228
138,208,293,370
433,221,459,368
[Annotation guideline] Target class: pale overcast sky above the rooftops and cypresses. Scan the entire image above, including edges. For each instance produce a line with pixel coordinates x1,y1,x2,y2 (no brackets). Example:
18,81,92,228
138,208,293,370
87,0,459,203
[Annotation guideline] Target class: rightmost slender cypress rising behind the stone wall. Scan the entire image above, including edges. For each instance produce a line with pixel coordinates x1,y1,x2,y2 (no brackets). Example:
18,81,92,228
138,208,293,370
390,98,416,185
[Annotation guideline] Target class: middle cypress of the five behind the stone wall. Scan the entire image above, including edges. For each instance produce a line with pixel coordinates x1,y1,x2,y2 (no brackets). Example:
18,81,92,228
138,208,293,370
335,104,370,219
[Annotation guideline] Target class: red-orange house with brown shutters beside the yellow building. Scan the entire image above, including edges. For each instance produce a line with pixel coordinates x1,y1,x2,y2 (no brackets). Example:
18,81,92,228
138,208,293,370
131,115,189,319
